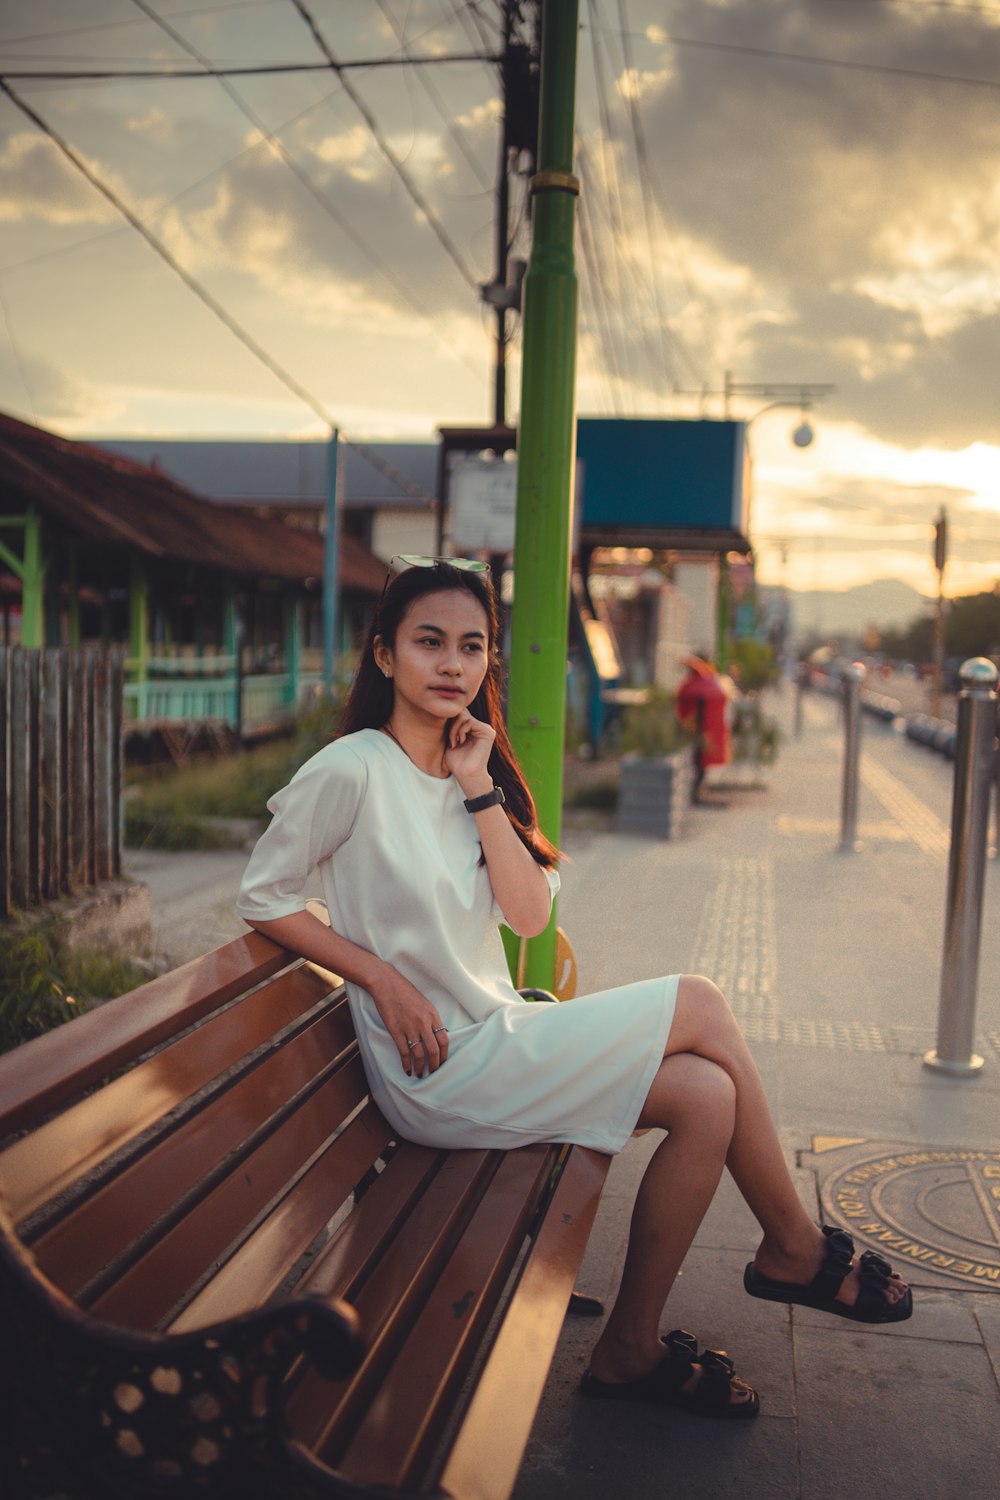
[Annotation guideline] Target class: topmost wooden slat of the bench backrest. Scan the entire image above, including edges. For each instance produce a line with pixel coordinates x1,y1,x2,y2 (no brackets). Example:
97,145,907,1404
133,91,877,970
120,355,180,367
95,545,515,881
0,932,292,1137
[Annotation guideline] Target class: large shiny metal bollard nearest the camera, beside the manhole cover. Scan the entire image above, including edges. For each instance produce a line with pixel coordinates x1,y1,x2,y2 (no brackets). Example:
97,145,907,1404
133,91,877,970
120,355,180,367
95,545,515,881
924,657,997,1079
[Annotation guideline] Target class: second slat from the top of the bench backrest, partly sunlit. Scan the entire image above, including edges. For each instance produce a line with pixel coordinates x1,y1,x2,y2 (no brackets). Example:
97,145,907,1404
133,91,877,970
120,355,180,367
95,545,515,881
0,966,346,1221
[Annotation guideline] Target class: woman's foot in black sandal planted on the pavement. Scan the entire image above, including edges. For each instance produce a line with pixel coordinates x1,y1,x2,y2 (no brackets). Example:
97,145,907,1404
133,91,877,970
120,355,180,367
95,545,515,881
580,1329,760,1416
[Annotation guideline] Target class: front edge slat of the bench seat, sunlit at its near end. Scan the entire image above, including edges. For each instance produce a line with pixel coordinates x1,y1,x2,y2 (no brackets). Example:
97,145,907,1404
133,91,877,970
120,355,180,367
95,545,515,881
439,1146,612,1500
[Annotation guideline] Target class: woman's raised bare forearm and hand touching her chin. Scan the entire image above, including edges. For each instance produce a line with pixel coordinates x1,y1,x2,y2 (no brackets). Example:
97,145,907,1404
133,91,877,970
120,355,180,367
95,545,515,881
445,710,552,938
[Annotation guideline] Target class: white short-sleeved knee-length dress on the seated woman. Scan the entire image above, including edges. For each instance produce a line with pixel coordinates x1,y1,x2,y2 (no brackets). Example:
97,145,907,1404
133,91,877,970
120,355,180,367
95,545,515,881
237,729,678,1152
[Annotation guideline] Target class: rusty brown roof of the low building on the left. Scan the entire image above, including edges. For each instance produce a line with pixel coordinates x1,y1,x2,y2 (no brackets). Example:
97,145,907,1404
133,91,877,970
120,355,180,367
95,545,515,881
0,414,385,594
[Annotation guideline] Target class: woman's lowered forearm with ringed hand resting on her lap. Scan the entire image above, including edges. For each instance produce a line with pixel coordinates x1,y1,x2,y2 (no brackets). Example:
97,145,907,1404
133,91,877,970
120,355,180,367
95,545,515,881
246,911,448,1073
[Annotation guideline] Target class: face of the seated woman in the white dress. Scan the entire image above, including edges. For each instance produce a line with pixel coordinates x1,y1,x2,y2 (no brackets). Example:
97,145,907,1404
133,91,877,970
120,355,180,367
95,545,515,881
375,588,489,720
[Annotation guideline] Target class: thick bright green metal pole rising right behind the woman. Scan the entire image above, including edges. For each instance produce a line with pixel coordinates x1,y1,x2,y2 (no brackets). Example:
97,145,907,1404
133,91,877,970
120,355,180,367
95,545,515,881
508,0,580,989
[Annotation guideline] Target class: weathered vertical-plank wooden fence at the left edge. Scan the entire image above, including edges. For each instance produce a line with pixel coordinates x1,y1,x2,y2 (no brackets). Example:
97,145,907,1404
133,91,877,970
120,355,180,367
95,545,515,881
0,647,124,917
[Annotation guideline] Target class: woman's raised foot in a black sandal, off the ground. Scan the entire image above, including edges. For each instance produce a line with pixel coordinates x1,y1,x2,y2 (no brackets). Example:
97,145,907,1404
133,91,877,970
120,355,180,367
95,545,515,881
744,1226,913,1323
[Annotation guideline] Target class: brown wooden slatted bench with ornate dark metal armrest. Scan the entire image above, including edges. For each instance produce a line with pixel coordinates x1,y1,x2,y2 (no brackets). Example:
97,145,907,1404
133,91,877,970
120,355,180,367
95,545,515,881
0,933,609,1500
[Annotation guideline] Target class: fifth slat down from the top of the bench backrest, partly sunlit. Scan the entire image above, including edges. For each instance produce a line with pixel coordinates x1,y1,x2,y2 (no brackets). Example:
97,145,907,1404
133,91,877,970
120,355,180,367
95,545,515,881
169,1103,393,1334
